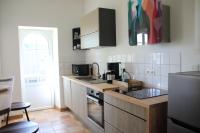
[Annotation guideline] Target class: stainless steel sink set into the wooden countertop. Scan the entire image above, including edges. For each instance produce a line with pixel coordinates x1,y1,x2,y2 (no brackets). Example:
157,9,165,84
76,77,106,84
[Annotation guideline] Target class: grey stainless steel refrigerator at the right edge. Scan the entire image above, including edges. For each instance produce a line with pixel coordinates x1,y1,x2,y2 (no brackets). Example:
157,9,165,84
168,72,200,133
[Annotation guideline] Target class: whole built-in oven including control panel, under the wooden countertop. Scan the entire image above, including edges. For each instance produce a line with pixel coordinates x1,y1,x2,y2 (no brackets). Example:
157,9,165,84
87,88,104,128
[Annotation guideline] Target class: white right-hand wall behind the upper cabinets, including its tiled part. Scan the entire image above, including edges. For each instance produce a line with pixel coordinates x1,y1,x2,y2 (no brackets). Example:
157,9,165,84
84,0,200,89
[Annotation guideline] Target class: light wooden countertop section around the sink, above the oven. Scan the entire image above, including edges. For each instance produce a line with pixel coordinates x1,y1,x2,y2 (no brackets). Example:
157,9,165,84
63,76,119,92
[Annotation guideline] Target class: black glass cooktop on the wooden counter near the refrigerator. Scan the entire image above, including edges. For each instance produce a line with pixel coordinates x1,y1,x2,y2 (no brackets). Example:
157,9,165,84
124,88,168,99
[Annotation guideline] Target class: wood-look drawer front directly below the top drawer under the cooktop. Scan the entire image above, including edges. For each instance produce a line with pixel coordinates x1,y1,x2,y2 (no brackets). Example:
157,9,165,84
104,103,146,133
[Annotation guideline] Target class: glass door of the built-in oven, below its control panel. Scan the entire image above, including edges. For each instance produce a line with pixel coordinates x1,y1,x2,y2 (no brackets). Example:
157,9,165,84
87,95,104,128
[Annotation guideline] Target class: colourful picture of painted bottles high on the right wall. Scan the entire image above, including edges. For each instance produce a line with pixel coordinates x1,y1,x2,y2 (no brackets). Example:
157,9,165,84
128,0,169,46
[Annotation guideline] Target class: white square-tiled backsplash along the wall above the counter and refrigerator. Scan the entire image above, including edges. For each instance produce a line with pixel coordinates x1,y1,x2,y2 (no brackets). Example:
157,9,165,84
82,49,200,89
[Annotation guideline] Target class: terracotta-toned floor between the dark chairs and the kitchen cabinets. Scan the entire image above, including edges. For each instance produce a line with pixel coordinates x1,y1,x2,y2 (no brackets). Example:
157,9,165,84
9,109,91,133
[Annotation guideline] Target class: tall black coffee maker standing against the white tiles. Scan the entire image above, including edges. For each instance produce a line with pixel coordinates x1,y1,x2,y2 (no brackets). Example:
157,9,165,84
107,62,122,80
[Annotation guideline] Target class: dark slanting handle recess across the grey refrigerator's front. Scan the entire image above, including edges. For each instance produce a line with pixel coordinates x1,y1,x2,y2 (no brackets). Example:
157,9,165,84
170,118,200,133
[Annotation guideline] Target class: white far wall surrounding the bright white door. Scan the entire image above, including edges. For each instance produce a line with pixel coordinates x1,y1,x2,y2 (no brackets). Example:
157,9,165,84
0,0,85,107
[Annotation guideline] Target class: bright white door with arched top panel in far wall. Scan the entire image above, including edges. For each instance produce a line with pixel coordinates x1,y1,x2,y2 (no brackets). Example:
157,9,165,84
19,27,58,110
